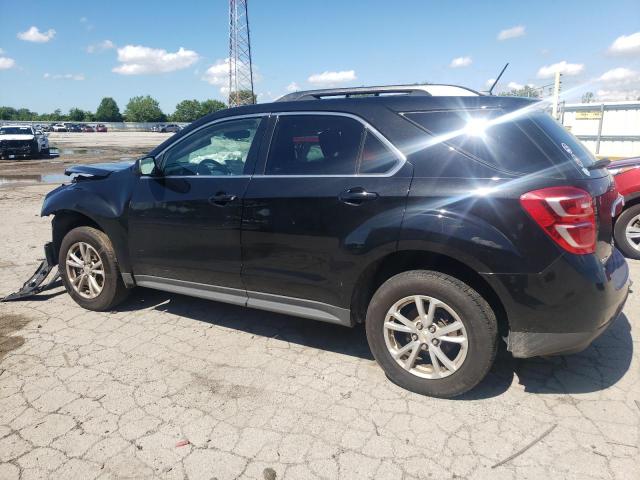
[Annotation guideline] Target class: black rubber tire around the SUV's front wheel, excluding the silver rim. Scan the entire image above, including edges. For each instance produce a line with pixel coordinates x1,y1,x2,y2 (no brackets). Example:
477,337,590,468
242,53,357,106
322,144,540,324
58,227,129,312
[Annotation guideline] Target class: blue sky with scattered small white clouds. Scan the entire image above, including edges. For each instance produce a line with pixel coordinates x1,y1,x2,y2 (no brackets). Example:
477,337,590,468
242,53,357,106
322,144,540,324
0,0,640,113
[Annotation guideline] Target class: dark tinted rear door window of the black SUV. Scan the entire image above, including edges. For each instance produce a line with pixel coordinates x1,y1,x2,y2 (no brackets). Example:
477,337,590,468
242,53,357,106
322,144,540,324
265,114,364,175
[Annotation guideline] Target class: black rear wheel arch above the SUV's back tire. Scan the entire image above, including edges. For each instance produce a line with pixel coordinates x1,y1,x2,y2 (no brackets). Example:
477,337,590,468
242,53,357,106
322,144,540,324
351,250,509,335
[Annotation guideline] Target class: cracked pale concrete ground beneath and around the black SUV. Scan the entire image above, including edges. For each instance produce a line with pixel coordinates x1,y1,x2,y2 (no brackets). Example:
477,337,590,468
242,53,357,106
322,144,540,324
0,182,640,480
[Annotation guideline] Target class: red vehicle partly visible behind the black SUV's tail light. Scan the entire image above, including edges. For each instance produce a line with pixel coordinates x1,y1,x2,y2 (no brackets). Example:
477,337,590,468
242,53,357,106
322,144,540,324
609,157,640,260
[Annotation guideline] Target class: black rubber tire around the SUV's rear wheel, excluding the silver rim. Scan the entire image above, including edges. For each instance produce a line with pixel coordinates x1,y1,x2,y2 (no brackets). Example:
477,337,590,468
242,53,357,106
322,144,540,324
366,270,498,398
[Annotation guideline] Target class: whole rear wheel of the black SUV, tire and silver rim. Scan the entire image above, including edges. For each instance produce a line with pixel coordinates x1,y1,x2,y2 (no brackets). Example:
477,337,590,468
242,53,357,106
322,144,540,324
366,270,498,398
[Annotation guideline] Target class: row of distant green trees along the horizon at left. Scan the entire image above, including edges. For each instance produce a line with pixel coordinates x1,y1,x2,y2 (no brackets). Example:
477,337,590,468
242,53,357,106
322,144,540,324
0,92,255,122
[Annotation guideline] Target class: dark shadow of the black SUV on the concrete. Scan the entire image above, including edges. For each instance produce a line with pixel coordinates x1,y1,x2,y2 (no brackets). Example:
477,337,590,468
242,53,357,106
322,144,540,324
20,288,633,400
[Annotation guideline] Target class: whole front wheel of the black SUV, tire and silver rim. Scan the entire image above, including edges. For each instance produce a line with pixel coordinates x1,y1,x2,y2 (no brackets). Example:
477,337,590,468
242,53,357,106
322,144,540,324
58,227,128,311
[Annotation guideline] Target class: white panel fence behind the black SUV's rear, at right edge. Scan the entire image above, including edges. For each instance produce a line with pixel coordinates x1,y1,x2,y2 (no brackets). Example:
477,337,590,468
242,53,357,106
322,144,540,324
561,102,640,159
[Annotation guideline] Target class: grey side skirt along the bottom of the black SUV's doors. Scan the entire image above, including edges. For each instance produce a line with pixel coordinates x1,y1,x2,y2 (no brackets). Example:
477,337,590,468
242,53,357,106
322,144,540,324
135,275,353,327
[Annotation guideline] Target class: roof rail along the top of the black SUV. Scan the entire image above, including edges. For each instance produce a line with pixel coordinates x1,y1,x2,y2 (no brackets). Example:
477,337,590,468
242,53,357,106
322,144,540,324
276,84,481,102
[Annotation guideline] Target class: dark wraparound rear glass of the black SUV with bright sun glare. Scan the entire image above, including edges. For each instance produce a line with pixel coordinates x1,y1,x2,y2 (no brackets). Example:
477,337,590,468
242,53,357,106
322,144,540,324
405,109,595,174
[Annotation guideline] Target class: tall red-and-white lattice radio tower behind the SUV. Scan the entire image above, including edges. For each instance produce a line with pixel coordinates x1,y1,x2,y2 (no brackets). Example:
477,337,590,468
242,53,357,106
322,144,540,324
229,0,255,107
